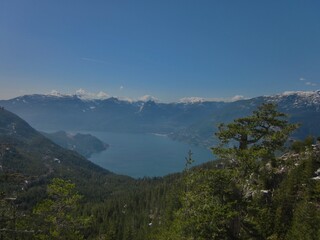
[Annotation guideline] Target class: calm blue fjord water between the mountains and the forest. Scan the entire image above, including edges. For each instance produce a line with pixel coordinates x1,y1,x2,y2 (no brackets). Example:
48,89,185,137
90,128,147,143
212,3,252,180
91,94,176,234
89,132,213,178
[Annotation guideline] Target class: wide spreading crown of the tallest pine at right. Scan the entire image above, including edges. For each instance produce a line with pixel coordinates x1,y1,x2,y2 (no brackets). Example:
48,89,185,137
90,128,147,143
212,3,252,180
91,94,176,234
212,103,297,159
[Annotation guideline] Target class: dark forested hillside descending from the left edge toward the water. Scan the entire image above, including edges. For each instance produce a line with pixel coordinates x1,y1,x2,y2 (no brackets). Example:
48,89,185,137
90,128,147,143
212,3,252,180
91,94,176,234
0,109,133,204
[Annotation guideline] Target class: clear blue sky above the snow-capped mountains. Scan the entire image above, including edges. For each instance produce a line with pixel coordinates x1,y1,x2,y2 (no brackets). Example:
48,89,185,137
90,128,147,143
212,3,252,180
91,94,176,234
0,0,320,102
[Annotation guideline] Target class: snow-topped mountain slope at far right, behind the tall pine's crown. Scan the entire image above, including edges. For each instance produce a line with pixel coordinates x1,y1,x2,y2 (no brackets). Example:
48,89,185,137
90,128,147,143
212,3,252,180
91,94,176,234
171,91,320,146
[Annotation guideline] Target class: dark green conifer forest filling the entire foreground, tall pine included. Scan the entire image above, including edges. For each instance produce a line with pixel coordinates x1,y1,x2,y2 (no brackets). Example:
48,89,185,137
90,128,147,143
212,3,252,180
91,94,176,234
0,104,320,240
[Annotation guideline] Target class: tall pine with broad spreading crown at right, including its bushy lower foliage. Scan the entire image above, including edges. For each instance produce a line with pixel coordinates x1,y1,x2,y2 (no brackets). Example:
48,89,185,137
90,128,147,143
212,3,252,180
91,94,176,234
174,103,297,240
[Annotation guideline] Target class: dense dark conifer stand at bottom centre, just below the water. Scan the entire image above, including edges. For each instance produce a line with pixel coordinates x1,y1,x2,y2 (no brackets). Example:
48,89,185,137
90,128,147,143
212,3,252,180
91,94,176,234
86,175,182,240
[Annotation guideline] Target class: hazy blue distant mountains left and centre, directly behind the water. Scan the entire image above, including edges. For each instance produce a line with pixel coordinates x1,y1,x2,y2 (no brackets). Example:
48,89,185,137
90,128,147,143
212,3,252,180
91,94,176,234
0,95,224,133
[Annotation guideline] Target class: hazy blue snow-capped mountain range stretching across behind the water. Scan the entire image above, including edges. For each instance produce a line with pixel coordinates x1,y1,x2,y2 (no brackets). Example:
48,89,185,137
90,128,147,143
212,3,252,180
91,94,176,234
0,91,320,146
